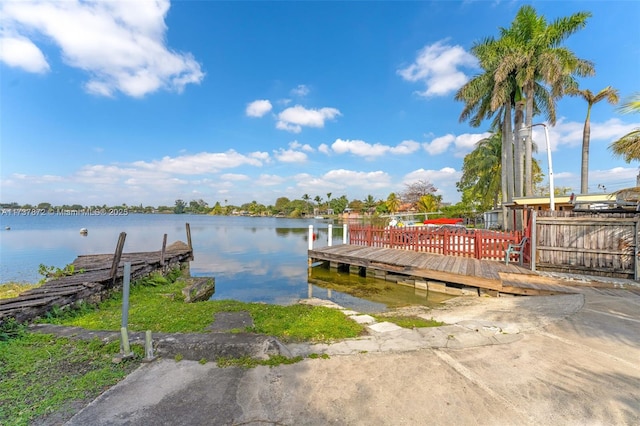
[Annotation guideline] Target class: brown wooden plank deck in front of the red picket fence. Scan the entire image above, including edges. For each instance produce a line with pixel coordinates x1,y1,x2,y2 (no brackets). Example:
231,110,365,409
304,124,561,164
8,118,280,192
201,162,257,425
308,244,574,295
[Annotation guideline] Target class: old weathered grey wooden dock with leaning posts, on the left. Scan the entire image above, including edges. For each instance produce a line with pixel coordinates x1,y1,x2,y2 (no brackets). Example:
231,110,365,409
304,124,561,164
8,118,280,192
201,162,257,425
0,240,193,324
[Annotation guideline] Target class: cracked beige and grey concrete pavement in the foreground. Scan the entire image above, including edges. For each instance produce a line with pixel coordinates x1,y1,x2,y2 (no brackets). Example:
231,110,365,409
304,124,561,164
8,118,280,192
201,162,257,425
67,288,640,425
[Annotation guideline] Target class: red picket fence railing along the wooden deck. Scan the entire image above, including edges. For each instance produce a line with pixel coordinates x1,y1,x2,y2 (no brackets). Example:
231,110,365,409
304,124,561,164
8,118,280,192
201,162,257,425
349,225,528,261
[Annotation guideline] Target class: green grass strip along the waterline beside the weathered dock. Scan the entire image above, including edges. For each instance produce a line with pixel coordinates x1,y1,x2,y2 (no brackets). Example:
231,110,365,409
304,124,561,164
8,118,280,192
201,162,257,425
44,272,364,342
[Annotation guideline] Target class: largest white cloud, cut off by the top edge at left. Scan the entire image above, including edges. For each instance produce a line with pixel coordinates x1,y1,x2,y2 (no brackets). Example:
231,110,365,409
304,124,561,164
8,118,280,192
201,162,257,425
1,0,204,97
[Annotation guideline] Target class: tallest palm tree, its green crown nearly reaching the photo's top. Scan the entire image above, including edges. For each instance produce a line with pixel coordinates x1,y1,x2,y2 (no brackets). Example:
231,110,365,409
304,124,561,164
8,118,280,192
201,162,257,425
496,5,594,195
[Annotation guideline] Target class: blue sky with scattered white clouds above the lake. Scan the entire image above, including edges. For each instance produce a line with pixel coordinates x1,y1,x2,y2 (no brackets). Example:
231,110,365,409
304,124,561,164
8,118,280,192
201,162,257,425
0,0,640,206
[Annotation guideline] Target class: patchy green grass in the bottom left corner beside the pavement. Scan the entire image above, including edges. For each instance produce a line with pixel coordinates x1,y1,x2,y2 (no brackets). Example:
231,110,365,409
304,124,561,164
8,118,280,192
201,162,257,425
0,332,143,426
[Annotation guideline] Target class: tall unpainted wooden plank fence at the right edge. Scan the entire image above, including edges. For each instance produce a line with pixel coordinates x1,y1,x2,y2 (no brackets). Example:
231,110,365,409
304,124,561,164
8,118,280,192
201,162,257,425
531,211,640,280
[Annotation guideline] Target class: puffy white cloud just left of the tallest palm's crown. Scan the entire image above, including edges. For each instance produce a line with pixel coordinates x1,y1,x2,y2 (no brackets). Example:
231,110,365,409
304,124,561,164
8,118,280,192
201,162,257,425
397,40,477,97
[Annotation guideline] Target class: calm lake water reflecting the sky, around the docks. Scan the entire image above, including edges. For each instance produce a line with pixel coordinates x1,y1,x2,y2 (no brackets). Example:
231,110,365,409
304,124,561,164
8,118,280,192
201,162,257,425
0,214,448,312
